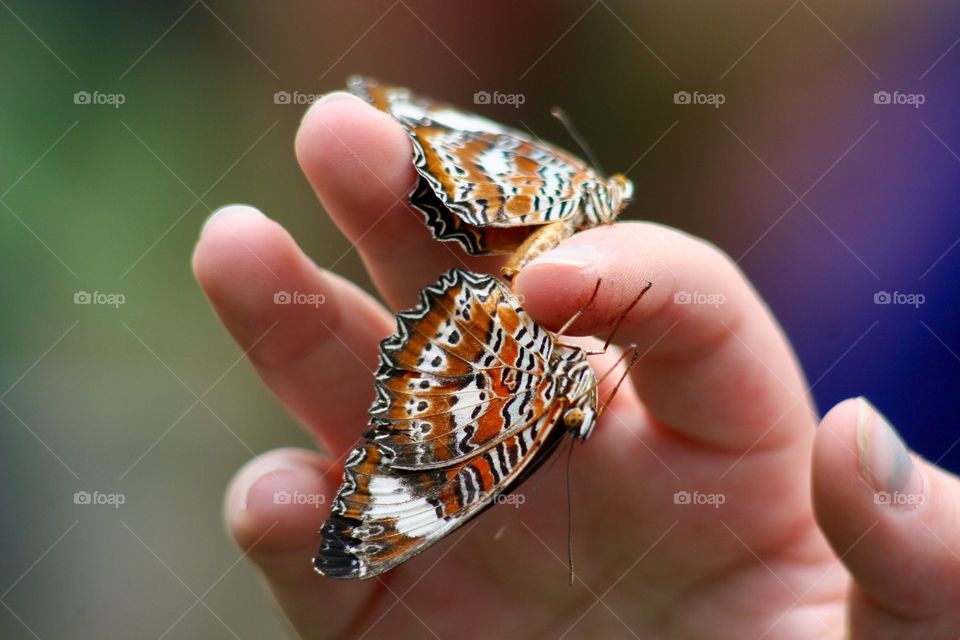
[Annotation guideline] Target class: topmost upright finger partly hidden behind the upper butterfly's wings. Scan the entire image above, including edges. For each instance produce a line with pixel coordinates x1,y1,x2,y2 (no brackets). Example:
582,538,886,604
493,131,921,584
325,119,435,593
296,93,501,309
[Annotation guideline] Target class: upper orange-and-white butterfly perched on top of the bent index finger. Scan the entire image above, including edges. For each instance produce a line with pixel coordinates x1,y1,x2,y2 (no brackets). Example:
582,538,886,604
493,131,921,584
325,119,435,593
347,76,633,279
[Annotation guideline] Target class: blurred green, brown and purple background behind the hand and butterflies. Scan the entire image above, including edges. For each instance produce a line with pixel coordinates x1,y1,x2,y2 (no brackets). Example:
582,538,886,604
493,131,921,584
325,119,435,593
0,0,960,640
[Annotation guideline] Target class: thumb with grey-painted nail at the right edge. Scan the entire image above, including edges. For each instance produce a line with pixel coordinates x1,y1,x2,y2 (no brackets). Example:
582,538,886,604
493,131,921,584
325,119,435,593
813,398,960,640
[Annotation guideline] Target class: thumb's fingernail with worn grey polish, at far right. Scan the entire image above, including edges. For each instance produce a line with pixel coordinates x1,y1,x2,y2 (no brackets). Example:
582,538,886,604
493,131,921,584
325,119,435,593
857,397,924,508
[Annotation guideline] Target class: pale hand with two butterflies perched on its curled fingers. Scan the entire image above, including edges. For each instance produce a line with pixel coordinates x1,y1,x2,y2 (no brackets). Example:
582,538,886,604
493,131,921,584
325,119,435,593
193,94,960,640
